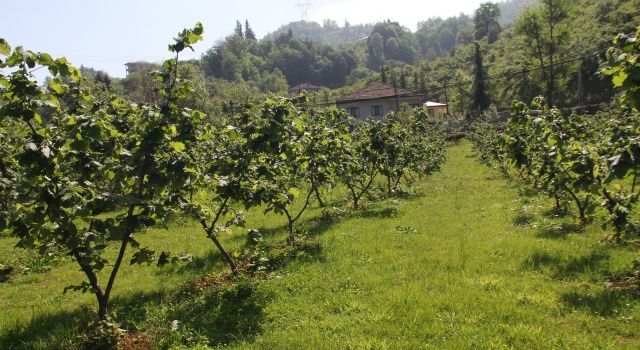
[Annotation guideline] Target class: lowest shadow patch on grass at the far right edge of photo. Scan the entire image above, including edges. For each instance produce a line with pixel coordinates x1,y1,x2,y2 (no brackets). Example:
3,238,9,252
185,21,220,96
560,288,640,317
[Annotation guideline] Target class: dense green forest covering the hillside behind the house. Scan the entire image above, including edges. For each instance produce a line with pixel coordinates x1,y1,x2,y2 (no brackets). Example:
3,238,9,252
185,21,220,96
94,0,640,115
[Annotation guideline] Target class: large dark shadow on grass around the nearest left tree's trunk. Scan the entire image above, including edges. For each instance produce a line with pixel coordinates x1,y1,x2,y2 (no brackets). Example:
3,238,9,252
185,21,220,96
0,280,267,349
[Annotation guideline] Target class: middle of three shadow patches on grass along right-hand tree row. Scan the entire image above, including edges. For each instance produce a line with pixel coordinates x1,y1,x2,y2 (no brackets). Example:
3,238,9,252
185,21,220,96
522,251,609,279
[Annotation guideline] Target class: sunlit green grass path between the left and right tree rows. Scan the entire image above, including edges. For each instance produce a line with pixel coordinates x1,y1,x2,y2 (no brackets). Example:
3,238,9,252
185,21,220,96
235,143,640,349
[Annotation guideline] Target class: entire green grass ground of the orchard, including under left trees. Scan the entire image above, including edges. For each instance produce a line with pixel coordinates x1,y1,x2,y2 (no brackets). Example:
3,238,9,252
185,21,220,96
0,142,640,349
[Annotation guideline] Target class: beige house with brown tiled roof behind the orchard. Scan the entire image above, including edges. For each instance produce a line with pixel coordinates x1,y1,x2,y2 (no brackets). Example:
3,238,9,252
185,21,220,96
336,83,424,119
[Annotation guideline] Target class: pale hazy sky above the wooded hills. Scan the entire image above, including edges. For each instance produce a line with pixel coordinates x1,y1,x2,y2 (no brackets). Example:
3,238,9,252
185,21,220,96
0,0,486,77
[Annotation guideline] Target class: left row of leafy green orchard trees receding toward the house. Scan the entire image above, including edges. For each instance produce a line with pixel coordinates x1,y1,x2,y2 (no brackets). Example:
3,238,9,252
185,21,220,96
0,24,444,320
